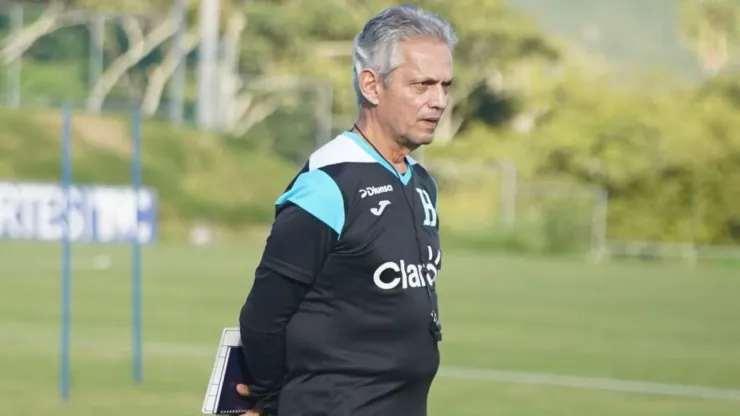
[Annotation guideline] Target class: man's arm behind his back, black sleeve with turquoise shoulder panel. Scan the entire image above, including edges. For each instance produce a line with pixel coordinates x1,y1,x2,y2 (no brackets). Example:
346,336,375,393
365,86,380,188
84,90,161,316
239,171,344,411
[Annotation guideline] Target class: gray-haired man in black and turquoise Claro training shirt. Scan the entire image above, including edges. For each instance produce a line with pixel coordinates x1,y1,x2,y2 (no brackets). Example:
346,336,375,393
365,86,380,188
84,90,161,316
238,6,456,416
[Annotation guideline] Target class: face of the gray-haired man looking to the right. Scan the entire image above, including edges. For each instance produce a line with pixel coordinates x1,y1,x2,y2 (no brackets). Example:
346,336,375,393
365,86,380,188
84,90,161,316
377,39,452,147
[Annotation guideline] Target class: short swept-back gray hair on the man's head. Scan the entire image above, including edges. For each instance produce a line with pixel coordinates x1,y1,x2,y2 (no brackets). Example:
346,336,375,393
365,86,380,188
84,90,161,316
352,5,457,105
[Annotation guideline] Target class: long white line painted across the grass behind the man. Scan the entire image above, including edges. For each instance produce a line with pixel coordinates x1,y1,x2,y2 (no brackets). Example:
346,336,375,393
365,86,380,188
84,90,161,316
0,331,740,402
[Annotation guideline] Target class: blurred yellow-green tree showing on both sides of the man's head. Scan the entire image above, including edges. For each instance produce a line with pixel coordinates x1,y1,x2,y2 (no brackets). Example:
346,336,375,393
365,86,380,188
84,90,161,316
243,0,559,141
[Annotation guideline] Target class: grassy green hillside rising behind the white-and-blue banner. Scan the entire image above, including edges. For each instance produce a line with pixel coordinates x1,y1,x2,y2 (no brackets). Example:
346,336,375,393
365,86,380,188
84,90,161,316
0,109,297,238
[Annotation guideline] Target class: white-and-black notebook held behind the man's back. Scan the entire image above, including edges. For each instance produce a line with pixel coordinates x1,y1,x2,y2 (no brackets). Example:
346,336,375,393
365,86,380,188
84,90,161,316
203,328,255,414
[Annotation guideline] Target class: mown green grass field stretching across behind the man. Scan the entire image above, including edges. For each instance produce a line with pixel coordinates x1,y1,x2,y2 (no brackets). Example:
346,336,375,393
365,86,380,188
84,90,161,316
0,243,740,416
